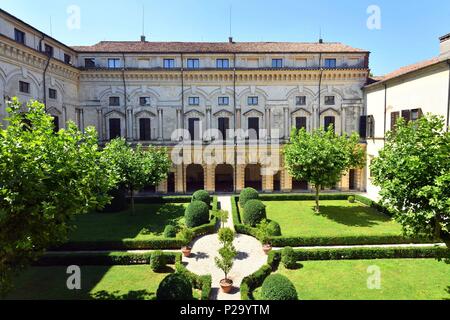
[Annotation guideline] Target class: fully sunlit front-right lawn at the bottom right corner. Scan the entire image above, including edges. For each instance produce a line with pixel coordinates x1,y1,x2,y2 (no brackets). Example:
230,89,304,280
255,259,450,300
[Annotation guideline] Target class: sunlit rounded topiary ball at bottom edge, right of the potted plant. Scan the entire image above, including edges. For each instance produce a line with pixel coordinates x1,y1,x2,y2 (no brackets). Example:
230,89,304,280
261,274,298,301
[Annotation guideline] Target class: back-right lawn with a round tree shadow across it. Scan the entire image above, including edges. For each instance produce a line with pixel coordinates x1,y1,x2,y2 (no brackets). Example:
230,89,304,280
264,200,402,237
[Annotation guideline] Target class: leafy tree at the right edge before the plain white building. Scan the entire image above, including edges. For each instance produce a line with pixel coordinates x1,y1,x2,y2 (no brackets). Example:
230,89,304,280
370,115,450,239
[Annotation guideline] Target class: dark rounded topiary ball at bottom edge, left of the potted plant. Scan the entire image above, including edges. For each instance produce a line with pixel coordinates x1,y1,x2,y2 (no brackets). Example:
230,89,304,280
156,273,192,301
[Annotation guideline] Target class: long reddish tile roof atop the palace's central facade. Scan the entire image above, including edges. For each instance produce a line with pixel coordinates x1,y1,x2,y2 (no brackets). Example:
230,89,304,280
72,41,368,53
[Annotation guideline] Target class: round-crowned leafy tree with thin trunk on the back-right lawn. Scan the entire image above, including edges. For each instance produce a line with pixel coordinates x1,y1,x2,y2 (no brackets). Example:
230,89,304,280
284,127,365,212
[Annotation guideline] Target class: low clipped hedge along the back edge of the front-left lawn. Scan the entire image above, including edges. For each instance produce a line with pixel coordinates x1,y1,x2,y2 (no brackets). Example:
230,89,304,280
34,252,181,266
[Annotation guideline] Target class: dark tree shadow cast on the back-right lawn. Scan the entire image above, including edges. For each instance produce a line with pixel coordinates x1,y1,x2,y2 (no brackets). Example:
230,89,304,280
319,206,391,227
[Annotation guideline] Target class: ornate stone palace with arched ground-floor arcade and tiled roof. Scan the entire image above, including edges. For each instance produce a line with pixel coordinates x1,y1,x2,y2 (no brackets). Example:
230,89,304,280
0,10,369,193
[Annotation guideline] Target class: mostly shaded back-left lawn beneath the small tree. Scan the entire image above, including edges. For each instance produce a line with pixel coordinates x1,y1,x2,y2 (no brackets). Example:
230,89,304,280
69,204,187,241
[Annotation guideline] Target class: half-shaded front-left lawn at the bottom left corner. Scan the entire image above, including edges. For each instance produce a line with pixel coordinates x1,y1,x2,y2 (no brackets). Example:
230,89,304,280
6,265,173,300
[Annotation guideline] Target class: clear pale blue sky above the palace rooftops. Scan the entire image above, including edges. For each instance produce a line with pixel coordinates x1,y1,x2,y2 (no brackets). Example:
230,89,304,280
0,0,450,75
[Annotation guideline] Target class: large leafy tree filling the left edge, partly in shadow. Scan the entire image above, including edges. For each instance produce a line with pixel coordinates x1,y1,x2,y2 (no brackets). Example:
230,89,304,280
0,98,117,294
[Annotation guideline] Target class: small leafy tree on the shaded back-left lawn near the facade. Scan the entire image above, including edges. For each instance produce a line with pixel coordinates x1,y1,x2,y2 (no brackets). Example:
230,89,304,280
104,138,171,214
